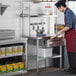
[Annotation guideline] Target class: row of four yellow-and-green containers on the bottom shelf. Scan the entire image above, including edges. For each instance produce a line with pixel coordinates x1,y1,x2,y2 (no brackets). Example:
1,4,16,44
0,62,25,74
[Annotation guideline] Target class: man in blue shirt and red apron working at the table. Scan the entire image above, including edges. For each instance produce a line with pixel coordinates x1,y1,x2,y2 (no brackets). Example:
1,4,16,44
55,1,76,73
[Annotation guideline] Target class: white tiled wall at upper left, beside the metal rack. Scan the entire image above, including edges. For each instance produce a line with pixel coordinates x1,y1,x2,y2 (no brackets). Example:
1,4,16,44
0,0,21,38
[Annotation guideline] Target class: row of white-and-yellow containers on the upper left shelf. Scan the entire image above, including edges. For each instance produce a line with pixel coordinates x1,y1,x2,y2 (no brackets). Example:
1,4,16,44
0,45,24,57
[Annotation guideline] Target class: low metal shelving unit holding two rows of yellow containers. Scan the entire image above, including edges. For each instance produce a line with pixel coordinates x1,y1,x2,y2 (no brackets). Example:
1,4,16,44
0,38,27,76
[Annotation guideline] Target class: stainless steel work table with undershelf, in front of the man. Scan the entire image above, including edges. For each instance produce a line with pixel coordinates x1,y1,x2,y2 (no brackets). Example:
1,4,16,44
25,36,64,72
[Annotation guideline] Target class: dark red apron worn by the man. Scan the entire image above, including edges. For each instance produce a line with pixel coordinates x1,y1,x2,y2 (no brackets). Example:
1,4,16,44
65,29,76,52
